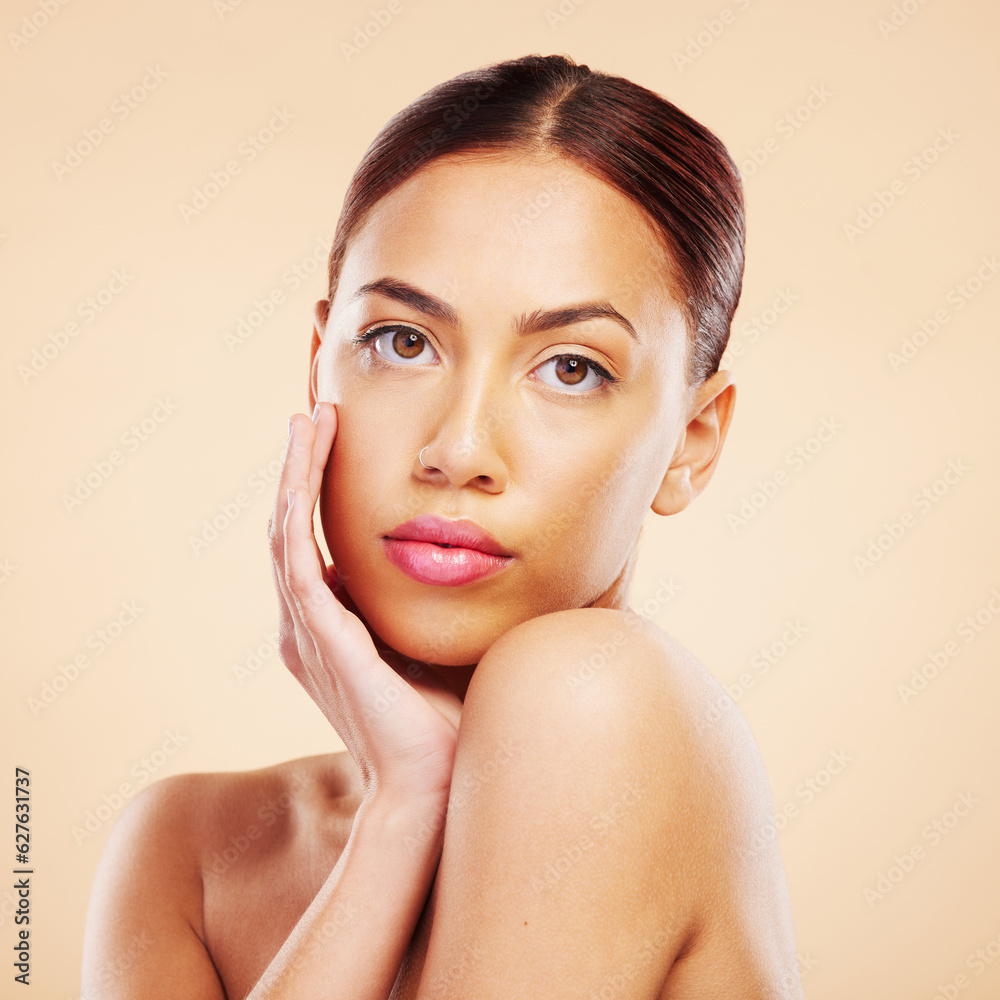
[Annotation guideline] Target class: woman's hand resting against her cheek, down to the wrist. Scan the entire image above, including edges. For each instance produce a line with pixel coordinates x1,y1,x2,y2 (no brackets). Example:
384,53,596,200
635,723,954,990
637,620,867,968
268,403,462,796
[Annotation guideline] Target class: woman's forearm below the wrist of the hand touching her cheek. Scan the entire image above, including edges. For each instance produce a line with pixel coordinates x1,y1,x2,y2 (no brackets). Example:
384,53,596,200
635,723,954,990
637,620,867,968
246,795,447,1000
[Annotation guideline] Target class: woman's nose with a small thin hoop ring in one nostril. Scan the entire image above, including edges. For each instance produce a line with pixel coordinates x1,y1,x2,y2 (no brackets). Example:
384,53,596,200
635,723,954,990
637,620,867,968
413,383,510,493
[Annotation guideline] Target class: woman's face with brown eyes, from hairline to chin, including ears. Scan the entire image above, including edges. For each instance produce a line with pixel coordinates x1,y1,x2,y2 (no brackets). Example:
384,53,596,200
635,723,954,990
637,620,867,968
312,154,732,665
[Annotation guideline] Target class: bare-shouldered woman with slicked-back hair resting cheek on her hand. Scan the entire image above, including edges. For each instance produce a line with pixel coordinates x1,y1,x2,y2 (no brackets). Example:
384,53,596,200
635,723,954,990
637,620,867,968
84,56,802,1000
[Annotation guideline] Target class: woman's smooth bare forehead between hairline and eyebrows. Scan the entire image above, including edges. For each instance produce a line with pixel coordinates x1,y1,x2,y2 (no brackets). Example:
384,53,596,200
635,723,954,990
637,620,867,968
339,153,675,325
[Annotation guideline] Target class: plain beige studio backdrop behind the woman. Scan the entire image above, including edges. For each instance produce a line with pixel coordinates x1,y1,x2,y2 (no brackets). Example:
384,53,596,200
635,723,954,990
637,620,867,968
0,0,1000,1000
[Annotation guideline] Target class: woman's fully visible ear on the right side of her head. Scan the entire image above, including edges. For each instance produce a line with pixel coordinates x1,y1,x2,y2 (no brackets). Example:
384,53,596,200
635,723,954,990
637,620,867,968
650,371,736,515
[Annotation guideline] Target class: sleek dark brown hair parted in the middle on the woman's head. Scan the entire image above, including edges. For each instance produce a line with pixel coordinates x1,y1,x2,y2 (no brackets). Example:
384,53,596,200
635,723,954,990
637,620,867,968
329,55,745,384
